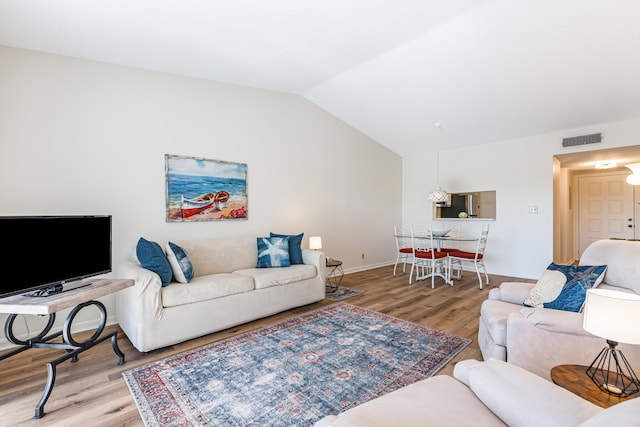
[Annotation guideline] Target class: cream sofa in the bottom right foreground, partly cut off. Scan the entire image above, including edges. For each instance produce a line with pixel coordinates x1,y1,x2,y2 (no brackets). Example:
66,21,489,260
315,359,640,427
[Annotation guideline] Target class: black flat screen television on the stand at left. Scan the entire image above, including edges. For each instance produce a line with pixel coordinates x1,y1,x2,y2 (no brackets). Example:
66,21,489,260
0,215,112,298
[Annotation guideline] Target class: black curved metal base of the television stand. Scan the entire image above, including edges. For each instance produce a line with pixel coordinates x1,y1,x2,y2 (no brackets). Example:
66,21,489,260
0,301,124,418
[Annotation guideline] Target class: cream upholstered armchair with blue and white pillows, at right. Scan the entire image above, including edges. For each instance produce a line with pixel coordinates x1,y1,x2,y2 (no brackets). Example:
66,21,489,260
478,240,640,379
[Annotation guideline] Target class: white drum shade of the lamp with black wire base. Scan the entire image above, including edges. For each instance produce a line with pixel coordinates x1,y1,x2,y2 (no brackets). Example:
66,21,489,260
582,289,640,344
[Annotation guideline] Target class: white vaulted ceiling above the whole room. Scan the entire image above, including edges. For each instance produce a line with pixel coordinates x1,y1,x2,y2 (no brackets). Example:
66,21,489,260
0,0,640,156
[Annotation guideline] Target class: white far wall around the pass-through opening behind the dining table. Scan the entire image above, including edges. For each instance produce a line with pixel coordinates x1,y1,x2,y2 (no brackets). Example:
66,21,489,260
403,118,640,279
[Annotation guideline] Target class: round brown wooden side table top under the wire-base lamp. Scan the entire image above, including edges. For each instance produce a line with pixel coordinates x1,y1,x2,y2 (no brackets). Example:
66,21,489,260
551,365,636,408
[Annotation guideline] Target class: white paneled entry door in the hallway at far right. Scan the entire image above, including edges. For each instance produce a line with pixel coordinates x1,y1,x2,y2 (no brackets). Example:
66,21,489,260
578,173,634,256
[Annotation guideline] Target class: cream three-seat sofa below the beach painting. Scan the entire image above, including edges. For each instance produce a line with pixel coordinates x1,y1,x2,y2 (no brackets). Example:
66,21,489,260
116,237,326,352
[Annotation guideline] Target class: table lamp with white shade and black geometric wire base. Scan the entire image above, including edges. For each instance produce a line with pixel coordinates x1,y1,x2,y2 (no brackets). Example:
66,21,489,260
582,289,640,397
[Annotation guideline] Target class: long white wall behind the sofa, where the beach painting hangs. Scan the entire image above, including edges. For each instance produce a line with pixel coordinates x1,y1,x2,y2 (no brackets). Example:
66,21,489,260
0,47,402,348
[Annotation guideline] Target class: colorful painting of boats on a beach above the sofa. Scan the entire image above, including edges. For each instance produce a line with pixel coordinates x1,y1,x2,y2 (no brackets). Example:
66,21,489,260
164,154,247,222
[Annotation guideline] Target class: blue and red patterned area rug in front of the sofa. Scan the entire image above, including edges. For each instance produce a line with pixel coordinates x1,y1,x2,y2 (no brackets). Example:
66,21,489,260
123,303,470,427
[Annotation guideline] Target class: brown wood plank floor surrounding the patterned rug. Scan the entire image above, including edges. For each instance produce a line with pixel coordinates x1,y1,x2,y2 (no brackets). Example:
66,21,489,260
0,266,526,427
